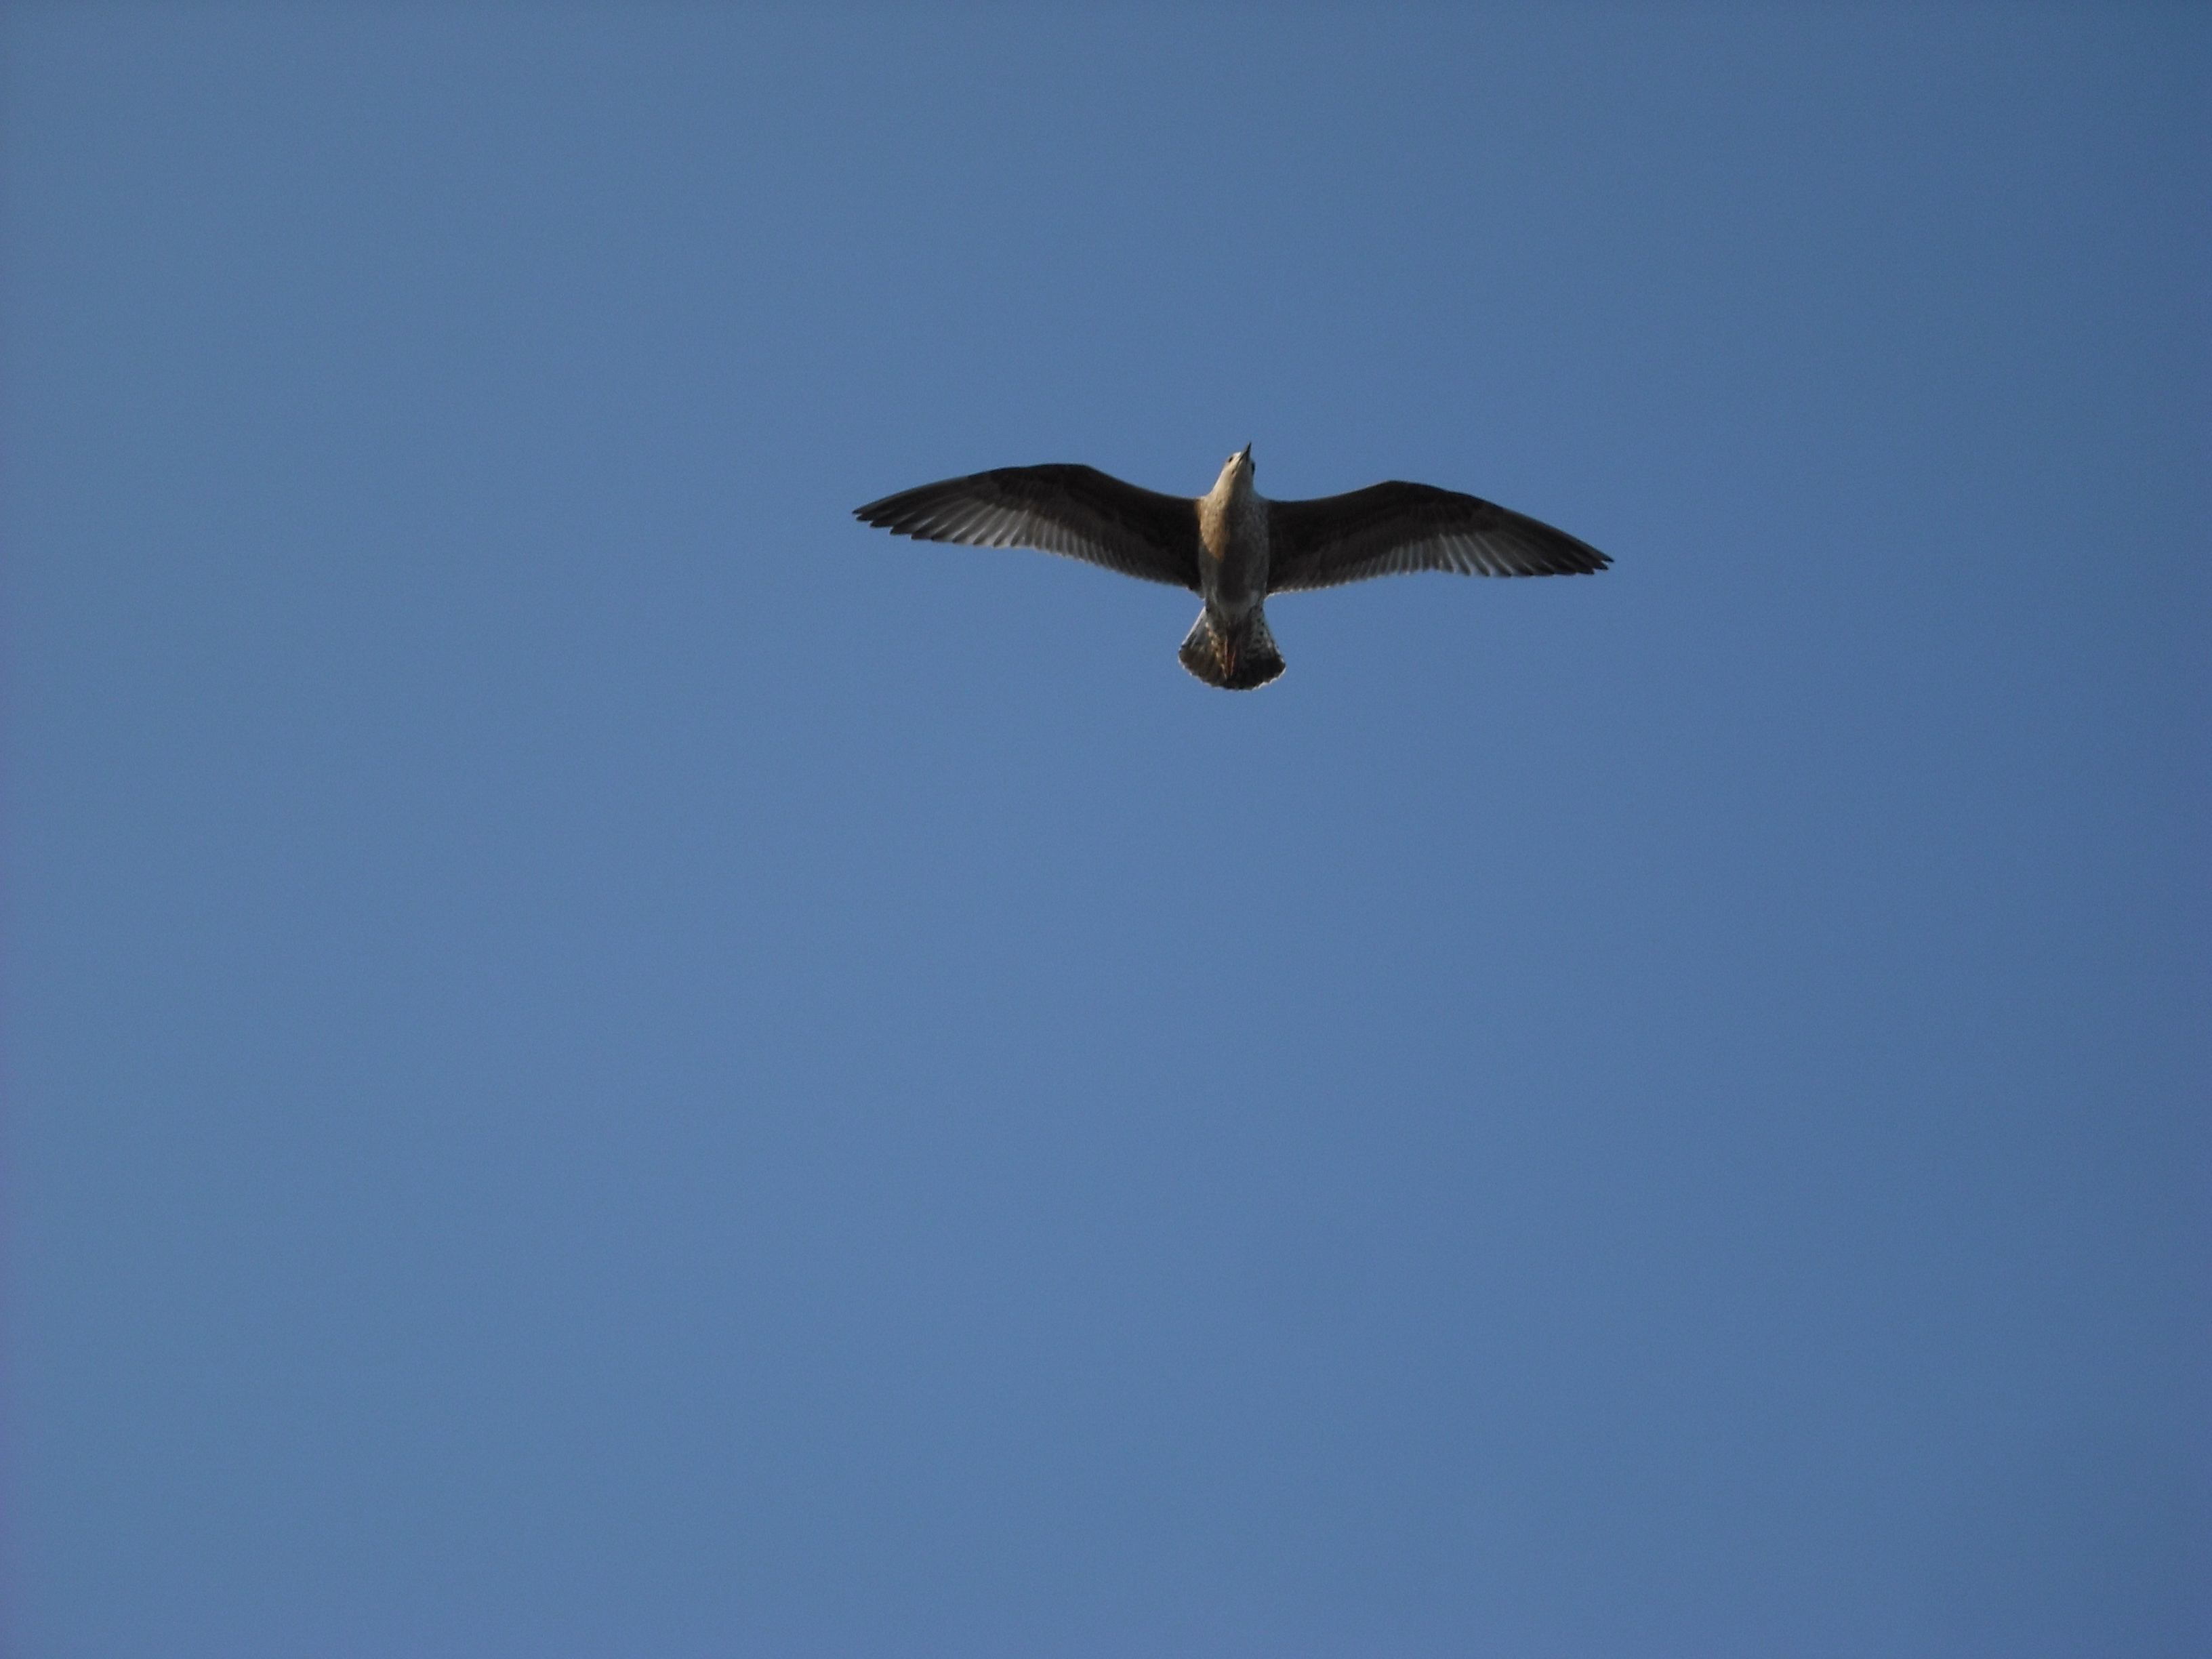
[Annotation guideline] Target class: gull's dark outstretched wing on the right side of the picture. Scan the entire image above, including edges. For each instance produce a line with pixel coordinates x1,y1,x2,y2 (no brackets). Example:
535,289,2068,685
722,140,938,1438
1267,485,1612,593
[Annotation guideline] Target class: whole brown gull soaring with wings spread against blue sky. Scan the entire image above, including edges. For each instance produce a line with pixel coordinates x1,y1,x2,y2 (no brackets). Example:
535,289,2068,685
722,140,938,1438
852,445,1612,690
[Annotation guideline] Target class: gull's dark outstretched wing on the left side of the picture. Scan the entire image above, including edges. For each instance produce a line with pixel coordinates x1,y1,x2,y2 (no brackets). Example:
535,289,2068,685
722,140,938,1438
852,467,1199,593
